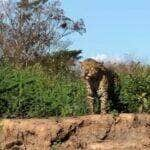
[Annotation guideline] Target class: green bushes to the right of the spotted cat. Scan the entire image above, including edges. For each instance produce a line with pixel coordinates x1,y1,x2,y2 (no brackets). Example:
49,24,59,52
108,61,150,113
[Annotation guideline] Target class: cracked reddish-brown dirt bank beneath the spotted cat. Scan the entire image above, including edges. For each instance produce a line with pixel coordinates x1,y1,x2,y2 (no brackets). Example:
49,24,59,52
0,114,150,150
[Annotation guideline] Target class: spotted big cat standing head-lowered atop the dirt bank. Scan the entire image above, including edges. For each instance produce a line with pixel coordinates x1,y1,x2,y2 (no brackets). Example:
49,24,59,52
81,59,109,113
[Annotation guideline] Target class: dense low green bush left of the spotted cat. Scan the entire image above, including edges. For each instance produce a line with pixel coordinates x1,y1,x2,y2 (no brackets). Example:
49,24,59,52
0,61,87,118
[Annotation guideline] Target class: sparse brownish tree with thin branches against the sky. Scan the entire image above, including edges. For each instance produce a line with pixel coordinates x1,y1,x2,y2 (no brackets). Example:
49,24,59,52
0,0,86,65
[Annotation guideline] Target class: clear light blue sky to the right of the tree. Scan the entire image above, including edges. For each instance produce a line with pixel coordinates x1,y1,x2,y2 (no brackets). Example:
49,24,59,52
62,0,150,63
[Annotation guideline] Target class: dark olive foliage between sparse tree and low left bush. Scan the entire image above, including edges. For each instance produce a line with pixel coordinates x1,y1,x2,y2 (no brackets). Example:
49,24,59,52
31,50,82,75
